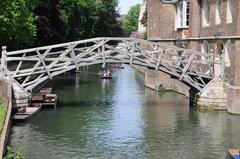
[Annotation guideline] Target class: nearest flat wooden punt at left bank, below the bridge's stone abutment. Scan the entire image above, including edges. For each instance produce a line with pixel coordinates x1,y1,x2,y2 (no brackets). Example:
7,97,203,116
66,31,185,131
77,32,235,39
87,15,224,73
12,106,42,122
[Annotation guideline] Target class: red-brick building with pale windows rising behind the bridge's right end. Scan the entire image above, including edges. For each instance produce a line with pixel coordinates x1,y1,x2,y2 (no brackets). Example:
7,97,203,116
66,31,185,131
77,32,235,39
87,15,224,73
147,0,240,114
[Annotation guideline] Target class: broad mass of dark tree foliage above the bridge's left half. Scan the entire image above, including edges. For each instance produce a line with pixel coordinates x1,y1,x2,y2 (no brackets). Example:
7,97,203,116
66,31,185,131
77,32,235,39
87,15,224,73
0,0,123,50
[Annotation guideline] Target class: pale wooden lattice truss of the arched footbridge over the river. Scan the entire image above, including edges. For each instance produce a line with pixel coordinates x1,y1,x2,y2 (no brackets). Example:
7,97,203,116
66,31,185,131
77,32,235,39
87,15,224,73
1,38,219,91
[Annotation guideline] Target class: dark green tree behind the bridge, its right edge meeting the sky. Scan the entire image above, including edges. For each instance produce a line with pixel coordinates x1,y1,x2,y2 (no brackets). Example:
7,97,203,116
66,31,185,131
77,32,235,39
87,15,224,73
60,0,122,41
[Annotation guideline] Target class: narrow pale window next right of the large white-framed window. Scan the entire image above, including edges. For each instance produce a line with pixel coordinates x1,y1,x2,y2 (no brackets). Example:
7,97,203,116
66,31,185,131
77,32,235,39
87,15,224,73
202,0,211,26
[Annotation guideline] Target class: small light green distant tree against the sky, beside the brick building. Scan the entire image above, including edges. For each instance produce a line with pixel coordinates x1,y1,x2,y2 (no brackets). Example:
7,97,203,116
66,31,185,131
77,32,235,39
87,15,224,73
122,4,141,35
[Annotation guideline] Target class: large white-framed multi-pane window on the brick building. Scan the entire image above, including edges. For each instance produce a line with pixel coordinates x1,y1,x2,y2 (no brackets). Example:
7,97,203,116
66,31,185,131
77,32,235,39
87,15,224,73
176,0,189,28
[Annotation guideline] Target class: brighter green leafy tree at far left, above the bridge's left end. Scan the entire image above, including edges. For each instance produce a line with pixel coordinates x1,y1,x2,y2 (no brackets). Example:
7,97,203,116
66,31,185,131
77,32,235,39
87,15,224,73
0,0,36,50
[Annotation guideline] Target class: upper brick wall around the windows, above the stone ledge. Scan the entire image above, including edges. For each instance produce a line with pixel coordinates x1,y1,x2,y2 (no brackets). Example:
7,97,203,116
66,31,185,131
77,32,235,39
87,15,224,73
148,0,240,39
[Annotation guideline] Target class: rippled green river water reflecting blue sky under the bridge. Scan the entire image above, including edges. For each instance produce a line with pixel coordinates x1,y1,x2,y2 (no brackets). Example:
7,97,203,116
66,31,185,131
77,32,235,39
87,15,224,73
9,66,240,159
